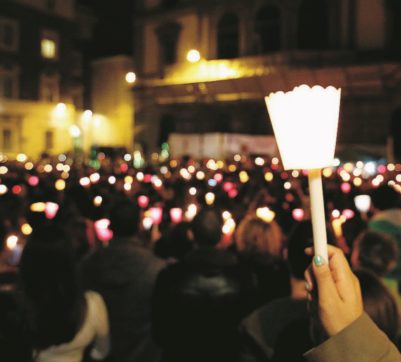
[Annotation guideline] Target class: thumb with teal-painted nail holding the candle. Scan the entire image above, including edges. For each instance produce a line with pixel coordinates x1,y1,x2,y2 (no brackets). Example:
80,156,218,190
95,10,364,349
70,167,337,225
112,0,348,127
312,255,339,305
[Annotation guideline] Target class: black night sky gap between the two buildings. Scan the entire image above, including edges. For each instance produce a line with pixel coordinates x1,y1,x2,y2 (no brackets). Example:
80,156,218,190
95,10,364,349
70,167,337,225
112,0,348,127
77,0,134,58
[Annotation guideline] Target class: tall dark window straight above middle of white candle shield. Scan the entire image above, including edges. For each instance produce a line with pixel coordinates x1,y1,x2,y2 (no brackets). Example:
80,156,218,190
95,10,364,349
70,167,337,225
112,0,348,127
298,0,329,50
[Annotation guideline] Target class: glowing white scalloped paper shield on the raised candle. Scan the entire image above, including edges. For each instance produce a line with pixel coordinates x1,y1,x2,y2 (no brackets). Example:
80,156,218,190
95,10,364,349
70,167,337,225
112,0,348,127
265,85,341,170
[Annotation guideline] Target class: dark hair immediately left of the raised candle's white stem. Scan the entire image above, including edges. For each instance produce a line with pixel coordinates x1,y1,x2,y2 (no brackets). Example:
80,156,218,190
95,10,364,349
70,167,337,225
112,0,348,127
287,221,313,279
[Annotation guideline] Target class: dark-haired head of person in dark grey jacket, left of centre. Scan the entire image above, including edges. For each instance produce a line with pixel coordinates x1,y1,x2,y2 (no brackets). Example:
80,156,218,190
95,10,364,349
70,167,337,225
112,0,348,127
110,200,139,237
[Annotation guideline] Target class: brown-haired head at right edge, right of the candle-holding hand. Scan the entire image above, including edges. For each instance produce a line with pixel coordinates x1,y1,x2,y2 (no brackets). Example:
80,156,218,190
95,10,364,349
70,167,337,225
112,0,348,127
351,230,398,276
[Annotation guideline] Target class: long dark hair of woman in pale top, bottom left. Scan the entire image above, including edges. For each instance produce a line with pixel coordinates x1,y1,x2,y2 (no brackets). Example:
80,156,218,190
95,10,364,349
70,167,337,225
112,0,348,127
19,225,85,349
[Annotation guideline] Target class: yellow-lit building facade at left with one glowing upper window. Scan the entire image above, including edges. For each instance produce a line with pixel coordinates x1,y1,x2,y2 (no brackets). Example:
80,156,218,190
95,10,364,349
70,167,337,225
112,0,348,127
0,0,94,158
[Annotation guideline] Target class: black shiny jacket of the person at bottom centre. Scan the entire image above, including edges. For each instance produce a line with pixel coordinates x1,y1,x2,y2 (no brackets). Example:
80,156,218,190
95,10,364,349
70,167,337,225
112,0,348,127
153,247,252,362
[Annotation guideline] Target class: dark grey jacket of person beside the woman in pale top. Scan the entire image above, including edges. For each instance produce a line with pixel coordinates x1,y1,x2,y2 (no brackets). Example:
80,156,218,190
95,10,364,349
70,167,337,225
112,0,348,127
83,238,165,362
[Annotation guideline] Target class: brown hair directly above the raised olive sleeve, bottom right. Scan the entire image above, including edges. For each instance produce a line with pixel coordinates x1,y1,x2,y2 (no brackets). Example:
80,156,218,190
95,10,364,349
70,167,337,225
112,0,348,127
355,269,400,342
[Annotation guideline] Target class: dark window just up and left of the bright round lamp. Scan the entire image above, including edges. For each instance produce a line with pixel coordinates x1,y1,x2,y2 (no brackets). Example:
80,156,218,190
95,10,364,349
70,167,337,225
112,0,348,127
156,23,181,65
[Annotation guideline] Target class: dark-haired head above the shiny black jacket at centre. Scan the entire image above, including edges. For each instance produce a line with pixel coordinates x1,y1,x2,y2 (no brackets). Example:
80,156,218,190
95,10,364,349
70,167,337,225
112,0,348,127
192,208,223,246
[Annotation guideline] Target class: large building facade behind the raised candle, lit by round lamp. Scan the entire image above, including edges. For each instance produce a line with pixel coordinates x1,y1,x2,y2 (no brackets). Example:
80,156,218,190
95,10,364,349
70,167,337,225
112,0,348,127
133,0,401,158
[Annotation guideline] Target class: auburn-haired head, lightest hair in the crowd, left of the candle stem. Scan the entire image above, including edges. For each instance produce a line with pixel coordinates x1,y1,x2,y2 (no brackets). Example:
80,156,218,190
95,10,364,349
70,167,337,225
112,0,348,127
235,215,283,257
